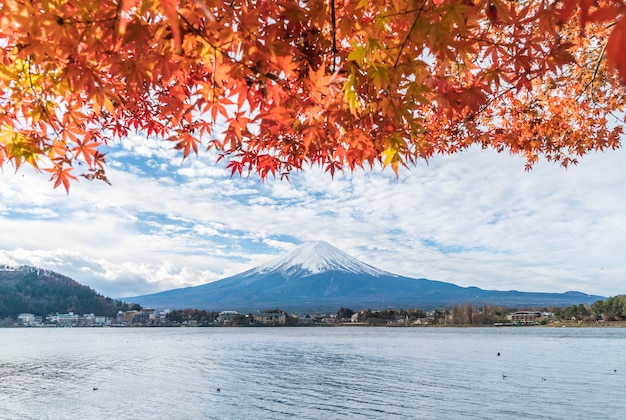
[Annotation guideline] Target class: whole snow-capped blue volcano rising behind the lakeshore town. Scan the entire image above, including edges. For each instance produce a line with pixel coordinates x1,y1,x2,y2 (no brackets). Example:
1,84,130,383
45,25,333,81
122,241,603,312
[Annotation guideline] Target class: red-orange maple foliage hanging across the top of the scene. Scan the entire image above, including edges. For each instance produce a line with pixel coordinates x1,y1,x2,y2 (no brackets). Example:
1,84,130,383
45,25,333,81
0,0,626,190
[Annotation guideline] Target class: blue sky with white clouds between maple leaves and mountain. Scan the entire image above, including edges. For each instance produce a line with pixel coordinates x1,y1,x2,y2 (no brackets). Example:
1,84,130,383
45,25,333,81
0,136,626,297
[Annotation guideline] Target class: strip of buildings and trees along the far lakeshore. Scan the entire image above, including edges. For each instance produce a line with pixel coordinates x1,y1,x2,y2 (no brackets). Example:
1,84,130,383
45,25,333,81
2,305,603,328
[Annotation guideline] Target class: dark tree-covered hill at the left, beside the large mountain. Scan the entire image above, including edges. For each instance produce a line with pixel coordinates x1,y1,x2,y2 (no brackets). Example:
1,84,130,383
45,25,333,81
0,265,136,318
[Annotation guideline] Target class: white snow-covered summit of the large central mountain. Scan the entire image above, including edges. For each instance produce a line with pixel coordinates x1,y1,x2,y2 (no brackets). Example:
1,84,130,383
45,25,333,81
254,241,390,276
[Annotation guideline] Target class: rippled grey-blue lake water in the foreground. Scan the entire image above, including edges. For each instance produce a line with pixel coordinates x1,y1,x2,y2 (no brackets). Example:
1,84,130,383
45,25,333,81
0,327,626,419
